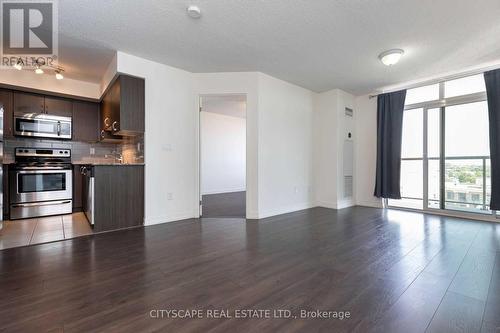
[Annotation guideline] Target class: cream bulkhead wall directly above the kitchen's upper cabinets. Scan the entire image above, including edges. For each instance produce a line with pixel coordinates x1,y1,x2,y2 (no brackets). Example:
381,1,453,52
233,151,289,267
0,69,101,99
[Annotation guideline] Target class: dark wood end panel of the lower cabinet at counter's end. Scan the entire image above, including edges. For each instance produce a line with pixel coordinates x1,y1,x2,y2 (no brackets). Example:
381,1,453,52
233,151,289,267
93,165,144,232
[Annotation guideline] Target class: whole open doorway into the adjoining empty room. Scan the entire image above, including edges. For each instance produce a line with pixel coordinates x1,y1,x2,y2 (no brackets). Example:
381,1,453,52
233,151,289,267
199,94,247,218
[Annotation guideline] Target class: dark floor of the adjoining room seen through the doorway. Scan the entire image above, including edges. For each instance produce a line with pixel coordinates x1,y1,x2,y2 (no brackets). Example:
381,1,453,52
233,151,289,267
202,191,246,217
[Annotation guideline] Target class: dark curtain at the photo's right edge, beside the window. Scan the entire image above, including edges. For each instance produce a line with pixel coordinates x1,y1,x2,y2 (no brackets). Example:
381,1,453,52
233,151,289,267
484,69,500,210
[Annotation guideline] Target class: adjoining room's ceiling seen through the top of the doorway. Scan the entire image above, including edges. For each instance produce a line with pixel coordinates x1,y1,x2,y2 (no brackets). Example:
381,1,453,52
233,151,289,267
201,94,247,118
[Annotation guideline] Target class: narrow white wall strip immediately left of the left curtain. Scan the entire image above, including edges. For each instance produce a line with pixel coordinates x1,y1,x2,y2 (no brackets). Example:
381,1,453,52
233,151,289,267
354,95,382,207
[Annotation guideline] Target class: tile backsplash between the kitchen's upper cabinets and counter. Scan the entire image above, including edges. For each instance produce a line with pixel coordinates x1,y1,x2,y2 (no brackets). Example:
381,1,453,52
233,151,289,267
3,136,144,164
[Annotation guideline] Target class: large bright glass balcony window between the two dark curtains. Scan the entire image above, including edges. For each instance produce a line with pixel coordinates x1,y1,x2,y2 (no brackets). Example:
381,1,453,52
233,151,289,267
387,74,491,214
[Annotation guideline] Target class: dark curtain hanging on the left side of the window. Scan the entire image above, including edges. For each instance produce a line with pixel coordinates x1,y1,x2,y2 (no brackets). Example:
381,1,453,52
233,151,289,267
374,90,406,199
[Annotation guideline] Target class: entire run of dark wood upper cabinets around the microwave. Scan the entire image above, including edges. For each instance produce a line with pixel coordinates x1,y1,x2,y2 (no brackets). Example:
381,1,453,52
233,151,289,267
0,75,145,142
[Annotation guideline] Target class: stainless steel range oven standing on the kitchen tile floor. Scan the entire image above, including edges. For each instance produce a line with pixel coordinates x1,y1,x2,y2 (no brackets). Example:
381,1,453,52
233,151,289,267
9,148,73,219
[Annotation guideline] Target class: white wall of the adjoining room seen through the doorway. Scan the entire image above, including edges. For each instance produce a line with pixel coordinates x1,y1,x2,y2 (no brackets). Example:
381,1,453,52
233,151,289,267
200,112,246,194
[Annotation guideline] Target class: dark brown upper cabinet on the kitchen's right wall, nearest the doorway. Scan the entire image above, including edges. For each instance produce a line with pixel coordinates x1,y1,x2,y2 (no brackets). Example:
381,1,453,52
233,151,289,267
101,75,144,137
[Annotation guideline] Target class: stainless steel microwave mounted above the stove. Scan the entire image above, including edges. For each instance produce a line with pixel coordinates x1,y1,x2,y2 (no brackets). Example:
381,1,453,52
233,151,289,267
14,113,72,139
